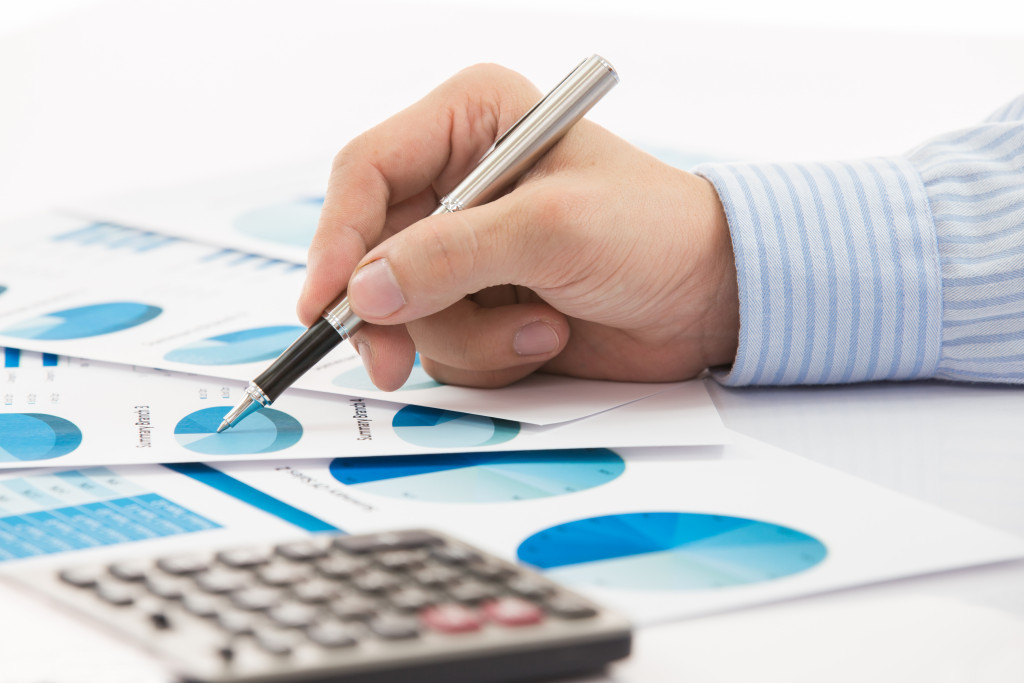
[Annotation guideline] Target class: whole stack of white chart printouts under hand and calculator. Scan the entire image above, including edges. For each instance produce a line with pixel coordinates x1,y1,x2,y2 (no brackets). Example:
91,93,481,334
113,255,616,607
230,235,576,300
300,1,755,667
0,161,1024,643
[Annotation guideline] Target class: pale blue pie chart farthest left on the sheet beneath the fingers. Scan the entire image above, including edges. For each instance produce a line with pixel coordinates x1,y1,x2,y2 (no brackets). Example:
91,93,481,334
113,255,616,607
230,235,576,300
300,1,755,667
3,301,162,339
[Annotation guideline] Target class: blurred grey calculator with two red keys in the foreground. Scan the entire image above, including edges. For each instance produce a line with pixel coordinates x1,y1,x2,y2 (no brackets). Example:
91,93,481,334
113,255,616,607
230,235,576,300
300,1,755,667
14,529,632,683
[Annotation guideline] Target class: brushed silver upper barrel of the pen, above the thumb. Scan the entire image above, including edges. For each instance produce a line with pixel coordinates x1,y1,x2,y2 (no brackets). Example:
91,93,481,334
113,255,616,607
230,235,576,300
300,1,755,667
441,54,618,212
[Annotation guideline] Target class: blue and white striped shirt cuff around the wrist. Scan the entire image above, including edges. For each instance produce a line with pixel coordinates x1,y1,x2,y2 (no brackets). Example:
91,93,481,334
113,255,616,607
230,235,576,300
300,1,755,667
694,158,942,386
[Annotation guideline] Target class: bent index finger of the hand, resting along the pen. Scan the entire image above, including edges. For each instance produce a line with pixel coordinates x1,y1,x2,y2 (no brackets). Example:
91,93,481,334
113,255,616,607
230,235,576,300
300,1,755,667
298,65,538,325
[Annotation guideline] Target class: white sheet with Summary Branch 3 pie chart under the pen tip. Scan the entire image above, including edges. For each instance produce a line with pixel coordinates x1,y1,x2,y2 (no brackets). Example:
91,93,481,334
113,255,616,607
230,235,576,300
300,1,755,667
0,349,726,469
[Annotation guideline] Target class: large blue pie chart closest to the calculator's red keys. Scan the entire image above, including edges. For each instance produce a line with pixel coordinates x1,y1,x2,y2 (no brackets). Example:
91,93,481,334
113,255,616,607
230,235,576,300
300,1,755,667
517,512,827,591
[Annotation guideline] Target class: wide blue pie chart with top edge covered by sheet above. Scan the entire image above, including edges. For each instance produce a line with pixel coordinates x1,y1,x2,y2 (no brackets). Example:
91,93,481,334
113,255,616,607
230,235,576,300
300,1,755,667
331,449,626,503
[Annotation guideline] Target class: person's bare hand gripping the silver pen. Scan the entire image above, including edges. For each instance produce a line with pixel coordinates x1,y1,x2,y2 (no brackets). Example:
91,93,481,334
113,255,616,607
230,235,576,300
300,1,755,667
298,66,739,390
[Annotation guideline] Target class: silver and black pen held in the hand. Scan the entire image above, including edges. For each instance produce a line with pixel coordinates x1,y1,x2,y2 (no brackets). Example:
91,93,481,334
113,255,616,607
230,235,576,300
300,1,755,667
217,54,618,433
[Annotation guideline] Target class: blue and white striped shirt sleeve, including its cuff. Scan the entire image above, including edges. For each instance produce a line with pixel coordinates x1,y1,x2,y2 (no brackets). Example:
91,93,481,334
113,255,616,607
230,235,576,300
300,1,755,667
694,95,1024,386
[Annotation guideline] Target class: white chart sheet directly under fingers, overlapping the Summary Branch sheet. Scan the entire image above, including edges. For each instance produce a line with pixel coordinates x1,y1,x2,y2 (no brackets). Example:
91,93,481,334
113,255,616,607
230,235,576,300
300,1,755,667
0,216,679,424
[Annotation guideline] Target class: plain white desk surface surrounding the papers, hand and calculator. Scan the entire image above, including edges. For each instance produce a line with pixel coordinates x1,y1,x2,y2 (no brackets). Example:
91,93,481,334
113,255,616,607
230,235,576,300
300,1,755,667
0,0,1024,683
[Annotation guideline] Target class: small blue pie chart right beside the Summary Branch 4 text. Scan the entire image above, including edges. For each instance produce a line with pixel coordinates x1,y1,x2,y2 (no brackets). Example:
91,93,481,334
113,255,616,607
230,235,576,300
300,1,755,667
391,405,519,449
